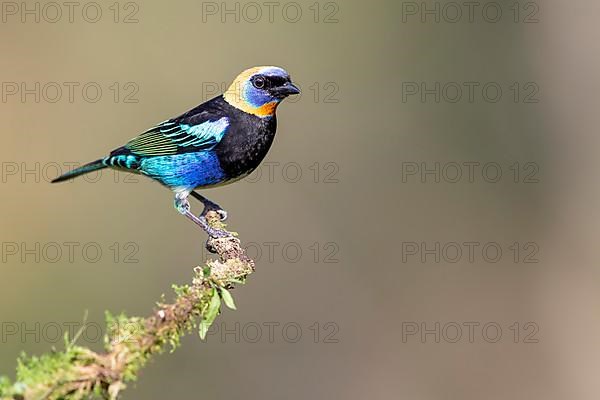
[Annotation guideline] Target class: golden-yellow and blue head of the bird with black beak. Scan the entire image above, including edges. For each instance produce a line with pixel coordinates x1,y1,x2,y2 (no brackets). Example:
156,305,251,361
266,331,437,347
223,67,300,118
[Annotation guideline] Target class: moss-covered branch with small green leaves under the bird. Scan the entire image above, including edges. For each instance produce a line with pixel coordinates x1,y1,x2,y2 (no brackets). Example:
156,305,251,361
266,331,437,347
0,212,254,400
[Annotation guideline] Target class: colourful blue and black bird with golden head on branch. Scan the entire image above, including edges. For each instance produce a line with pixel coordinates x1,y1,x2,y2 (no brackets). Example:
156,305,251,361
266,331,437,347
52,66,300,238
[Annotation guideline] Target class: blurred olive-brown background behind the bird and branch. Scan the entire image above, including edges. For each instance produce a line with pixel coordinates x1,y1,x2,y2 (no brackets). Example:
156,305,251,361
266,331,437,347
0,0,600,400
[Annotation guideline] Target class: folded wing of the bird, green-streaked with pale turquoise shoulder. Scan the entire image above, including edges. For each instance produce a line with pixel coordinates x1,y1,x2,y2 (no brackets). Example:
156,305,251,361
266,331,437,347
125,117,229,156
